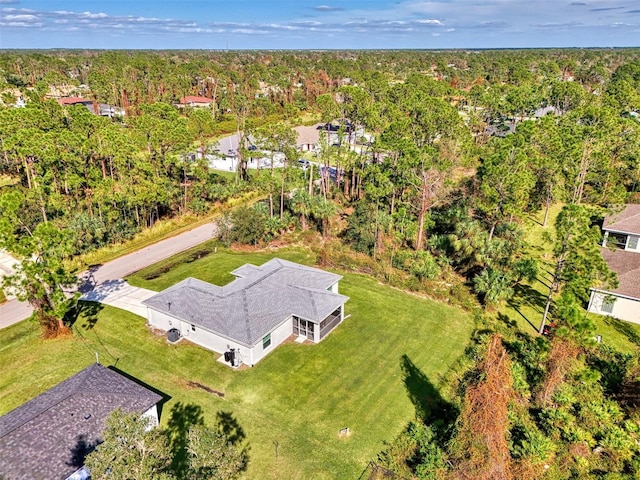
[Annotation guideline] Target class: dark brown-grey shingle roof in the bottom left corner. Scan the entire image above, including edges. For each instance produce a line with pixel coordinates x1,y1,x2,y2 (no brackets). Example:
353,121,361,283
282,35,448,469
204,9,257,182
0,363,162,480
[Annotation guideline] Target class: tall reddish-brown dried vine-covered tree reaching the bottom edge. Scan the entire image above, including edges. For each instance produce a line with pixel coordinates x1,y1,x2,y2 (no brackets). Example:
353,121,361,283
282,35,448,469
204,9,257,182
452,334,514,480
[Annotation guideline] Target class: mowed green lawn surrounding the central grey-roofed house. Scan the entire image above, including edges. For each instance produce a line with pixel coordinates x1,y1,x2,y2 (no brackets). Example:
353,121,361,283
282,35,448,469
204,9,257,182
0,249,474,479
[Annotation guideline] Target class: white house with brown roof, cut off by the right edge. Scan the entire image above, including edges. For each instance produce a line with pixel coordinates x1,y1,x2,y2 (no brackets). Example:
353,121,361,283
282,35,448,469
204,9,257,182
587,205,640,324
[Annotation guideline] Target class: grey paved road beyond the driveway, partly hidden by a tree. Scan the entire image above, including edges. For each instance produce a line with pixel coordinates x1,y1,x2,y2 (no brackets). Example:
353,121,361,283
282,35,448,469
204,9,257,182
0,223,215,328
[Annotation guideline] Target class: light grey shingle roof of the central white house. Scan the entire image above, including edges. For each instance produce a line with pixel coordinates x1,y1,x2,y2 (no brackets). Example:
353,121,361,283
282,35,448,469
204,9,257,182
143,258,348,346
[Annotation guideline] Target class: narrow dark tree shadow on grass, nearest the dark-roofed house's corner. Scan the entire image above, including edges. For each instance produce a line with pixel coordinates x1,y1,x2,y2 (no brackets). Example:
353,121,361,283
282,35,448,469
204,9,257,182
167,402,204,478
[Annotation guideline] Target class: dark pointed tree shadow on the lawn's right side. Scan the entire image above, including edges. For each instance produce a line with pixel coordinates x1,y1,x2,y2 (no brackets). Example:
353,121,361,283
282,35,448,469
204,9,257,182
400,354,457,423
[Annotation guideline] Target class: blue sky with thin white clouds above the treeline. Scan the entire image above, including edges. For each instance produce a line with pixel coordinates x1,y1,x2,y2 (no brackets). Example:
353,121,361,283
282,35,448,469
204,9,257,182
0,0,640,50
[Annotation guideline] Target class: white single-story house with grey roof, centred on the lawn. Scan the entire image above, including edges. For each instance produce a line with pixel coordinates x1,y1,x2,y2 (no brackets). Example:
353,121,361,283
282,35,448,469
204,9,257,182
143,258,348,366
